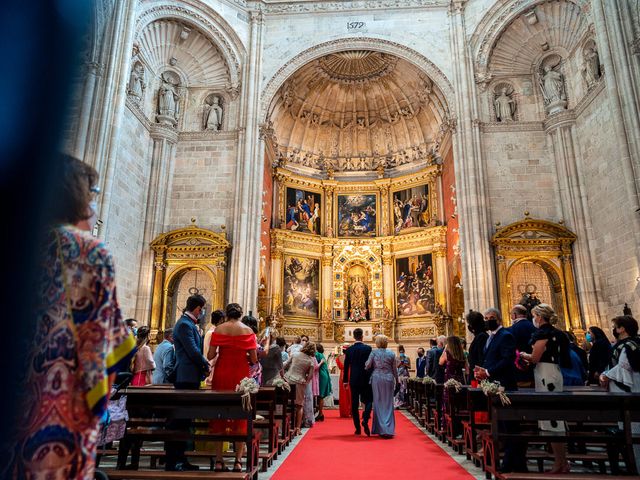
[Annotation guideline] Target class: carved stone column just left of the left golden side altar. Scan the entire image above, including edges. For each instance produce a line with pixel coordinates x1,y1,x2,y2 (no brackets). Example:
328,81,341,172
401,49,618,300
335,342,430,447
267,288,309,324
136,123,178,320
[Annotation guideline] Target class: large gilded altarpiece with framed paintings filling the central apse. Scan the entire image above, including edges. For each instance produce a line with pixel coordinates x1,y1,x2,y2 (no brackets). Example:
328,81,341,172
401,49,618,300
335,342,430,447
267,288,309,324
269,164,448,343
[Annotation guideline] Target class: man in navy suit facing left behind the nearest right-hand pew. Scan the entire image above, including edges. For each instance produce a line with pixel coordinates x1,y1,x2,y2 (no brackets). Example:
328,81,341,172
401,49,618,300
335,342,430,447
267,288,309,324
474,308,527,473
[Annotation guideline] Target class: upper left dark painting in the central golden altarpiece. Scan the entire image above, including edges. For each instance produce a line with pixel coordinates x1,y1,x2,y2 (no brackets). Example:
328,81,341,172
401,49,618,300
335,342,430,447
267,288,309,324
284,185,323,235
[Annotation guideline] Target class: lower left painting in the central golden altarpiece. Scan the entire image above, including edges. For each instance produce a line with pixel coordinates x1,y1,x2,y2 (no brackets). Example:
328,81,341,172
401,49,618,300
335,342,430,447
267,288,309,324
282,255,320,318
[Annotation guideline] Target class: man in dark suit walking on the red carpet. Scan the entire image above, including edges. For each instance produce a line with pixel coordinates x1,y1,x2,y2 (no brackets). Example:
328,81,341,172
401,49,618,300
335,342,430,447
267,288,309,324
342,328,373,436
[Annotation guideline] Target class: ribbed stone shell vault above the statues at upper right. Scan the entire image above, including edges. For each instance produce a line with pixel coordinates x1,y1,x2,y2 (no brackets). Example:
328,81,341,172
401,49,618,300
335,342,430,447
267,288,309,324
489,1,587,75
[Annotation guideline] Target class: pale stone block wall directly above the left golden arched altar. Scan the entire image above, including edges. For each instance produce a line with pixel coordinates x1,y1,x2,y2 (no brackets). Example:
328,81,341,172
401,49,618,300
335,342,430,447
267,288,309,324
165,133,237,237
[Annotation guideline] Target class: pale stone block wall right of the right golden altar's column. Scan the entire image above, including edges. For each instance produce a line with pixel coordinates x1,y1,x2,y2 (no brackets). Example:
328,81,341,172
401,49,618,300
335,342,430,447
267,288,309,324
576,89,640,320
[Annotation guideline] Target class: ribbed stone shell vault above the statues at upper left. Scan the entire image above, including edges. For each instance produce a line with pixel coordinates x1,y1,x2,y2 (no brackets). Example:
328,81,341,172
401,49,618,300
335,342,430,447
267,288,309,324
138,20,230,87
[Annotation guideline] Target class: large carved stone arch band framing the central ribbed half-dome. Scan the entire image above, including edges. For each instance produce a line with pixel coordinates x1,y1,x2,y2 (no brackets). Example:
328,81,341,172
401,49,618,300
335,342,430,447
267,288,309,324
259,37,455,122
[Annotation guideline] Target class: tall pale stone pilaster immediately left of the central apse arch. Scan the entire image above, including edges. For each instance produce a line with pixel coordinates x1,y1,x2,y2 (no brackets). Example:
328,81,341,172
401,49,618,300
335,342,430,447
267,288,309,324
229,10,264,311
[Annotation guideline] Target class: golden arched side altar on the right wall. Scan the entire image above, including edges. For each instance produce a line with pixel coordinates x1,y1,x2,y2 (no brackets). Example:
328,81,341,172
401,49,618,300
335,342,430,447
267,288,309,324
491,217,584,335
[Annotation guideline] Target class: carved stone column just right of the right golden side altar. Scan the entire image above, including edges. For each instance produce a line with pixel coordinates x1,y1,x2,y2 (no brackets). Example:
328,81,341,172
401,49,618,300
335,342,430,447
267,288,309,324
545,110,600,324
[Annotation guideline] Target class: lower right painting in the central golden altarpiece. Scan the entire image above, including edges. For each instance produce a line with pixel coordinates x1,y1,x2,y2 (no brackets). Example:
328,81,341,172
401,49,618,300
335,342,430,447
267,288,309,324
395,253,436,317
